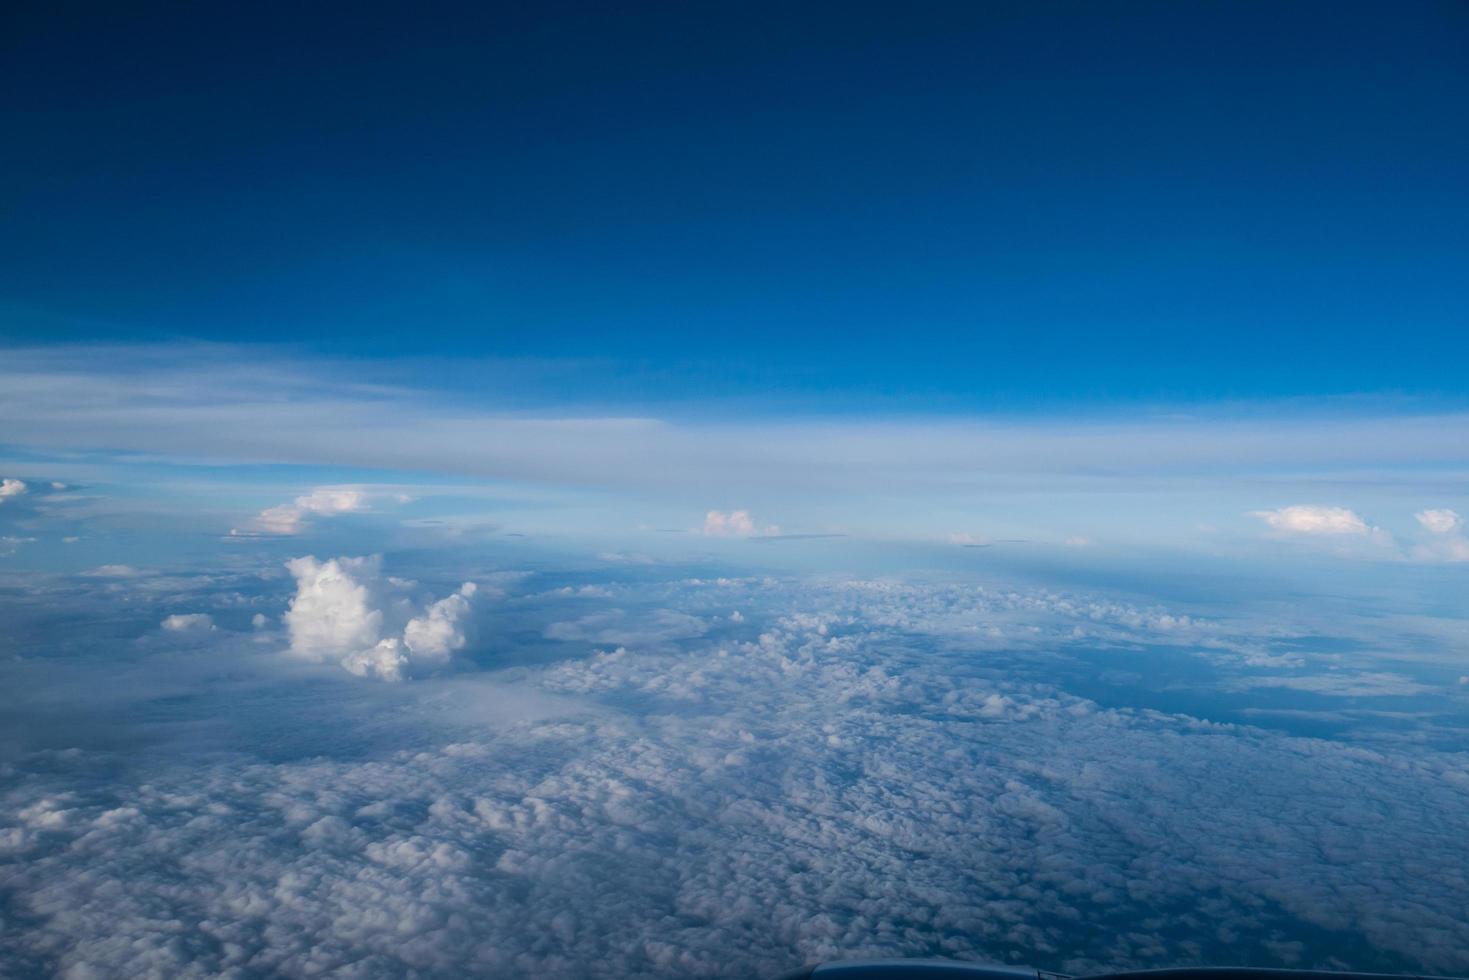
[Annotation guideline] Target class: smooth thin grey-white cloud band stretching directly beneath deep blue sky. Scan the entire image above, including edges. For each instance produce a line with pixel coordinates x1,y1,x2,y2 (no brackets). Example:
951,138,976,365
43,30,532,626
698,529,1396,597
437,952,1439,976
0,347,1469,499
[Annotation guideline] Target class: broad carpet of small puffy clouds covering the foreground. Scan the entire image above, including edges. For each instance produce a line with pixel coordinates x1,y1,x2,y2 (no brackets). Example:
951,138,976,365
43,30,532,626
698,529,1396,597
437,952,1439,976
0,558,1469,977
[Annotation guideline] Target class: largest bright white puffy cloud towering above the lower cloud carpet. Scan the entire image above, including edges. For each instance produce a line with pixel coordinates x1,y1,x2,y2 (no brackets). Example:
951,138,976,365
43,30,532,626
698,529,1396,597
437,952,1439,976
285,555,477,680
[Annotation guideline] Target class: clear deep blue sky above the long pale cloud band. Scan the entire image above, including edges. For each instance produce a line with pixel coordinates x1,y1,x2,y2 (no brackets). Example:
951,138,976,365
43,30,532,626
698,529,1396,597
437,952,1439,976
0,1,1469,408
